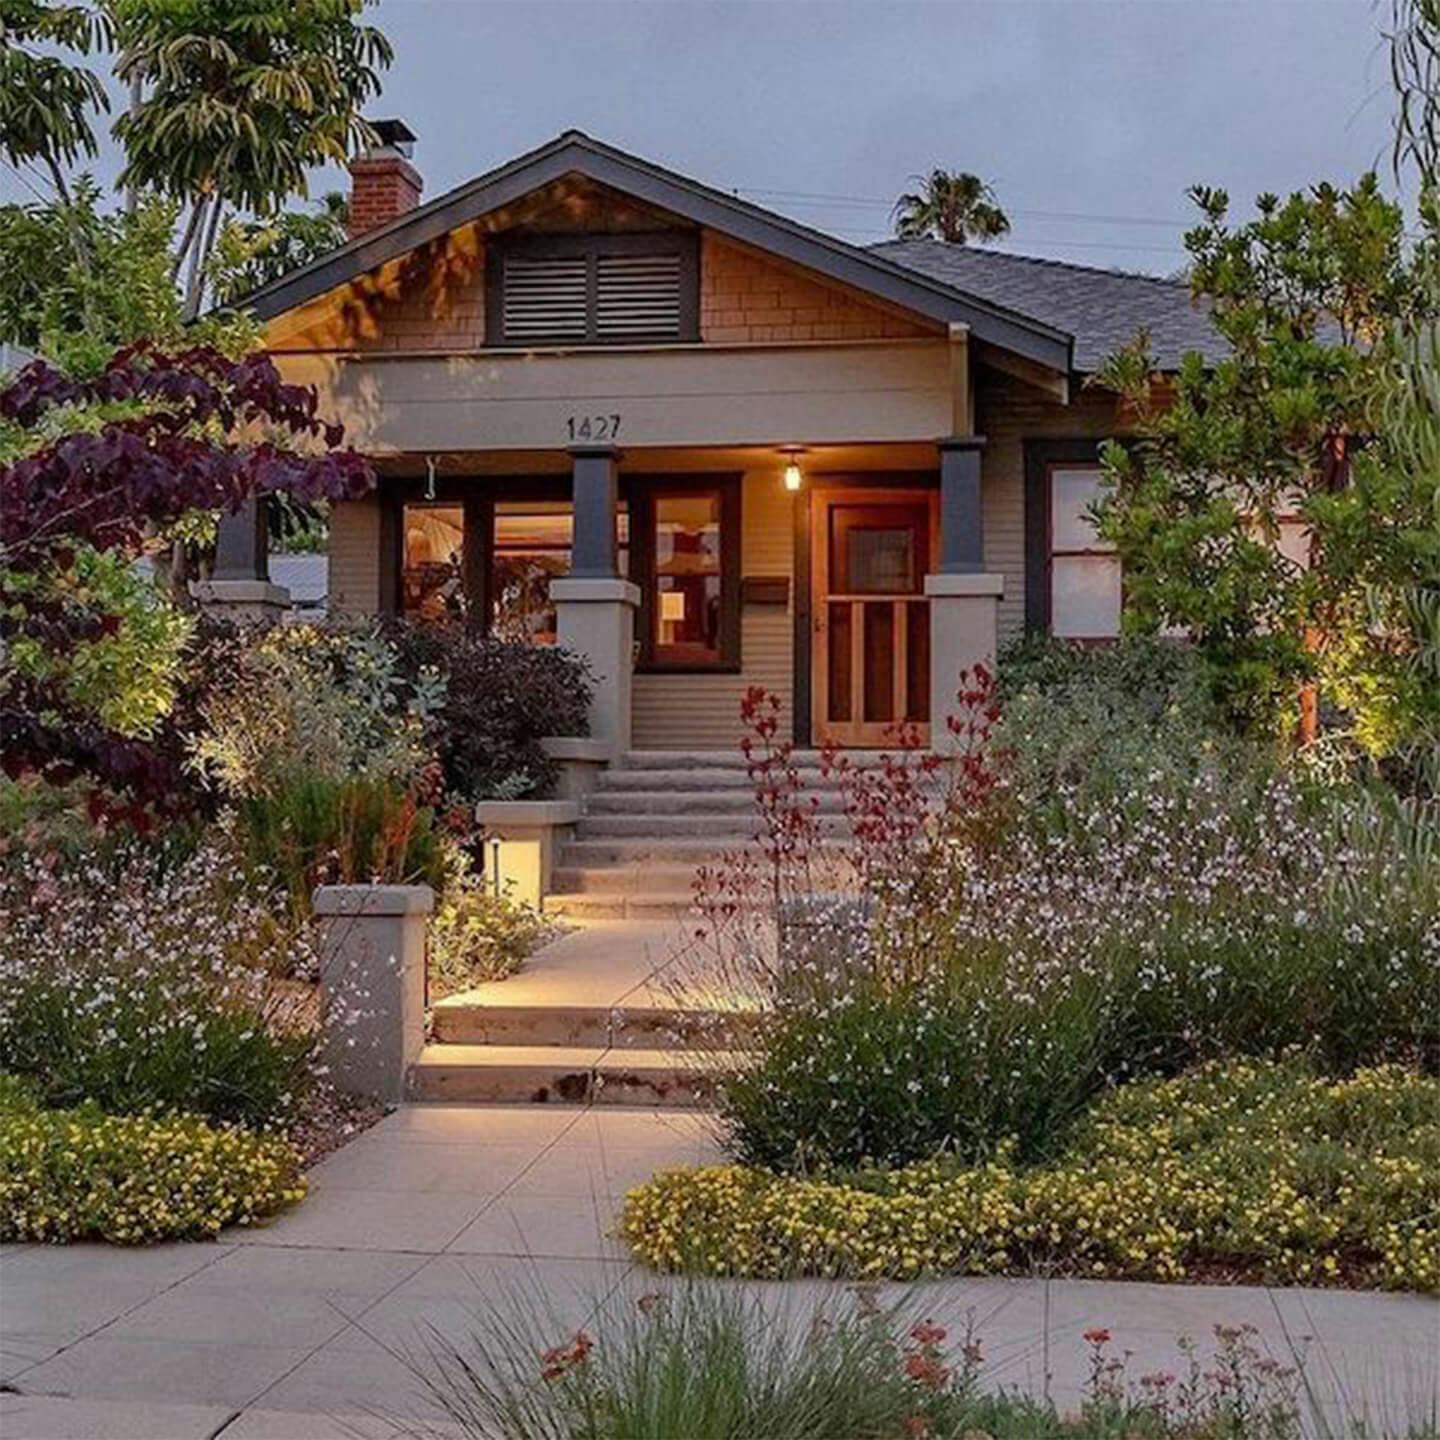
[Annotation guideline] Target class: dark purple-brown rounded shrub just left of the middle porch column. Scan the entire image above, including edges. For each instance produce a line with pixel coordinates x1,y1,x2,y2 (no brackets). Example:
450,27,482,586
390,624,593,801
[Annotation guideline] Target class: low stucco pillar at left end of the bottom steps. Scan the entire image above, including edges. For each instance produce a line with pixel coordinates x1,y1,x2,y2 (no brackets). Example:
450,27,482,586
314,886,435,1104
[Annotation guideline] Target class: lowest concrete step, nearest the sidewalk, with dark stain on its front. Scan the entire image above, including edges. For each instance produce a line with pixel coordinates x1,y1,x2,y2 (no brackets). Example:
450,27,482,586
410,1044,743,1106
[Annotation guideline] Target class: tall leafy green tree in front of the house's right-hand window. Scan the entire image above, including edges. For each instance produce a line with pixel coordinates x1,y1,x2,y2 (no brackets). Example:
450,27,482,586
1099,174,1440,753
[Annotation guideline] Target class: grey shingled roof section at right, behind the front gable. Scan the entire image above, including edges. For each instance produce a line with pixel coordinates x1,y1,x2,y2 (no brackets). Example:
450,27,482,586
870,240,1225,373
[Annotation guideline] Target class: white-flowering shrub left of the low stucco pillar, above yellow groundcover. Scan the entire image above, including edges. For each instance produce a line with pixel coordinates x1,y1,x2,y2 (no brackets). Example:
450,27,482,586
0,844,315,1126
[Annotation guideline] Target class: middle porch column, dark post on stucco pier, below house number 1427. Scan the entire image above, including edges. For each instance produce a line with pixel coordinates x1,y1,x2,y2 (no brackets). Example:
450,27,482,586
550,445,639,760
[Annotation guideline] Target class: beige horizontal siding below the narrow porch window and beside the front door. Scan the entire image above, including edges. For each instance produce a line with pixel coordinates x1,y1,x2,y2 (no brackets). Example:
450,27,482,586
632,468,795,750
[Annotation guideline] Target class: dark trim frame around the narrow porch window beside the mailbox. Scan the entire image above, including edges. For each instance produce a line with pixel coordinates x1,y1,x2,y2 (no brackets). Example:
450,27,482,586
626,472,743,675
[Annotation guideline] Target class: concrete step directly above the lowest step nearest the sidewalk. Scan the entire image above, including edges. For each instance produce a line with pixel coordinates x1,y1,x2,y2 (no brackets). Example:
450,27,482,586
431,995,752,1050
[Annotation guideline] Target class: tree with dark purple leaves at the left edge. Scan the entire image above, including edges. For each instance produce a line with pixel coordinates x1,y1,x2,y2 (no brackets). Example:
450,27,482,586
0,344,374,825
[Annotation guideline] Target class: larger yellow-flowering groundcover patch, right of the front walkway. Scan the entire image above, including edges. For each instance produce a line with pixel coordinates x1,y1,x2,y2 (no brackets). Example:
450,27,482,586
621,1061,1440,1292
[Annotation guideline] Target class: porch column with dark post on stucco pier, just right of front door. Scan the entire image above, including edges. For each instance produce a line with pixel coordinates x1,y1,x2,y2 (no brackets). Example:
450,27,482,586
924,435,1005,750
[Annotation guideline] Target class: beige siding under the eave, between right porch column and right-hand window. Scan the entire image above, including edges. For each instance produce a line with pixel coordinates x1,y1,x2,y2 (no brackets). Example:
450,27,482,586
976,373,1122,641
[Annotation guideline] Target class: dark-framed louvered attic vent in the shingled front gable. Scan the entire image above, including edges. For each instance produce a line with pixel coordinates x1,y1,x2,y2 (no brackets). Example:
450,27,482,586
487,232,700,346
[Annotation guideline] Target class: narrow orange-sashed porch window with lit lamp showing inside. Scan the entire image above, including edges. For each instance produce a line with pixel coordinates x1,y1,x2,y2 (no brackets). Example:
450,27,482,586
655,491,721,664
